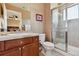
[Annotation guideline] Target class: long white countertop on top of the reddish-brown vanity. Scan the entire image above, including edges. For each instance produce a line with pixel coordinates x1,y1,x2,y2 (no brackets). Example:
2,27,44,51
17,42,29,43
0,33,39,41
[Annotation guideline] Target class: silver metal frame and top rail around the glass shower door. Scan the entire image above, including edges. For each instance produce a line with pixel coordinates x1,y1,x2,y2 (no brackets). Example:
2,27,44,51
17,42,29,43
51,3,79,52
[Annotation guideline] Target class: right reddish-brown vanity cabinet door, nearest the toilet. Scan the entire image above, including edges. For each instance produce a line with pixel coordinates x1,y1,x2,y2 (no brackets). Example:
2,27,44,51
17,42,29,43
22,44,39,56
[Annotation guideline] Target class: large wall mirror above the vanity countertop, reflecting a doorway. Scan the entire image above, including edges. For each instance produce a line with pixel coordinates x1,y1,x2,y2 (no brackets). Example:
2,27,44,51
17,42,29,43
5,3,31,32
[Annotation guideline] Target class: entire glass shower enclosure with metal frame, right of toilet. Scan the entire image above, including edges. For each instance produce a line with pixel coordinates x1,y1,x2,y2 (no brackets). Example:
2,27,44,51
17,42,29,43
51,3,79,55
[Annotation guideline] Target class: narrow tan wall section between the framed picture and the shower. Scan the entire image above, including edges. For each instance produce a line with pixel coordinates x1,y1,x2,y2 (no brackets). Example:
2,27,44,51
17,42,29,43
44,4,51,41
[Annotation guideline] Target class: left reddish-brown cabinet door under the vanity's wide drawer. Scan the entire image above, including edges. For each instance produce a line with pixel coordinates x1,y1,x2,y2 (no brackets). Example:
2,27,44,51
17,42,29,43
2,48,21,56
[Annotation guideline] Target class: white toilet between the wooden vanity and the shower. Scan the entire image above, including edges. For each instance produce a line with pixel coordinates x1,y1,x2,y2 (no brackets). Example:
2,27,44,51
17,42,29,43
39,34,54,56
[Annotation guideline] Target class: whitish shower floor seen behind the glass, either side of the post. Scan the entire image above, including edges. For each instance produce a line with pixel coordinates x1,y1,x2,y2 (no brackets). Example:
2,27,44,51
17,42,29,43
55,43,79,56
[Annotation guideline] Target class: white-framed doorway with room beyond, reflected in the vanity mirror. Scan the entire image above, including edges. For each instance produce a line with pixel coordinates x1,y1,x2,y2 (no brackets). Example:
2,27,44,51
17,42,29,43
7,10,22,31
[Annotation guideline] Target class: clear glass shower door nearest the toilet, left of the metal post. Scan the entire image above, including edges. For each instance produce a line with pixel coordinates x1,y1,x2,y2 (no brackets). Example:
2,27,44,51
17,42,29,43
52,8,67,51
